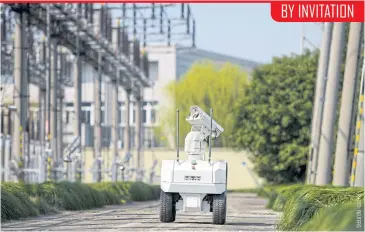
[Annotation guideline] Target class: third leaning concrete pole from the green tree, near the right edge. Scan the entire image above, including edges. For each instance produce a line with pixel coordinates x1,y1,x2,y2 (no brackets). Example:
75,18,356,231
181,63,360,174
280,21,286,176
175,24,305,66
333,23,363,186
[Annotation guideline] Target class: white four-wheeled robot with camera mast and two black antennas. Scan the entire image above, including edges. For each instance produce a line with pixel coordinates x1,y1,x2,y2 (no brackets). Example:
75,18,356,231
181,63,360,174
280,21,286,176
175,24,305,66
160,106,228,225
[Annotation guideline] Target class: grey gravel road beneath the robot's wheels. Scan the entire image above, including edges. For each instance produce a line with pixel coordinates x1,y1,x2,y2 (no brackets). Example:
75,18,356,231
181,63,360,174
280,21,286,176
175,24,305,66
1,193,279,231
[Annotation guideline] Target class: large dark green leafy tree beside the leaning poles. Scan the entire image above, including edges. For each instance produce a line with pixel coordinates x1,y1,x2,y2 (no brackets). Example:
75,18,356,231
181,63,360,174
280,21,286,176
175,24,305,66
234,51,318,183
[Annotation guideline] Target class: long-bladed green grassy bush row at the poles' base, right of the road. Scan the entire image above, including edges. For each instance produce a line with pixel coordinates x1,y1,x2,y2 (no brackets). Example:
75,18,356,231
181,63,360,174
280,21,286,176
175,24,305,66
258,185,364,231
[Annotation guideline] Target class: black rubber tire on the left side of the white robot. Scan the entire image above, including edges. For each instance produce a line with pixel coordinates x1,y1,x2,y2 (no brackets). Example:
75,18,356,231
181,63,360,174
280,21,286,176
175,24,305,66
160,190,176,222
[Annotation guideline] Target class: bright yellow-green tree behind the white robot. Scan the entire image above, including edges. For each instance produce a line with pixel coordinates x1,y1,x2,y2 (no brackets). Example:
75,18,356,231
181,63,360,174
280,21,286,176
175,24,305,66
156,61,249,146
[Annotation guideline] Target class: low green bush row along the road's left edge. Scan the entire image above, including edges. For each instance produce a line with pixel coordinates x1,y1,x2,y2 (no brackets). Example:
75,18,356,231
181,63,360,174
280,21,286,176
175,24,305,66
1,182,160,221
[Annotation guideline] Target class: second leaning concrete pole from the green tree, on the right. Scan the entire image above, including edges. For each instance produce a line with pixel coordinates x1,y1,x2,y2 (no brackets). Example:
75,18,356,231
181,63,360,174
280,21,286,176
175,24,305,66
315,23,345,185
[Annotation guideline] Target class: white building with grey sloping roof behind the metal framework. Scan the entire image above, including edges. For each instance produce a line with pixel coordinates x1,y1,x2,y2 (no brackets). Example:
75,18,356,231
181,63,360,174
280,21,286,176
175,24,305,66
3,46,259,148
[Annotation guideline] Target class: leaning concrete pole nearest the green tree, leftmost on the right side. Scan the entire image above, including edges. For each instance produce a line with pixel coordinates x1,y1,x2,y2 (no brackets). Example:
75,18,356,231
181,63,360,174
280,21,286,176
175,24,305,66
307,23,333,184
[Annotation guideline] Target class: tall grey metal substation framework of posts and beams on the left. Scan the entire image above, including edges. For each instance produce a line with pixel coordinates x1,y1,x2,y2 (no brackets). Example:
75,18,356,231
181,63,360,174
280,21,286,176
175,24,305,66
1,3,195,181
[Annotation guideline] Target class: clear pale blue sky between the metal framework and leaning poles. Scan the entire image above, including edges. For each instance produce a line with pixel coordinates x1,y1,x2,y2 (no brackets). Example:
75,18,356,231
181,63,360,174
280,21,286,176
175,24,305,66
190,3,322,63
